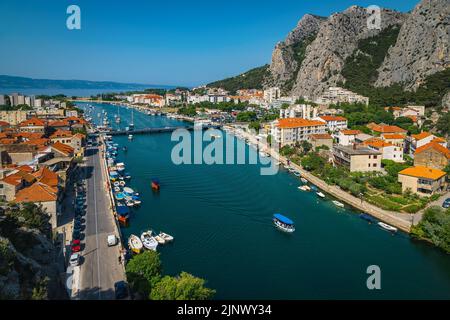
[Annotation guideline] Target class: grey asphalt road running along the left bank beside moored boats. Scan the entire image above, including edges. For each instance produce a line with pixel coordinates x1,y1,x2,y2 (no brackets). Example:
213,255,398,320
78,140,125,300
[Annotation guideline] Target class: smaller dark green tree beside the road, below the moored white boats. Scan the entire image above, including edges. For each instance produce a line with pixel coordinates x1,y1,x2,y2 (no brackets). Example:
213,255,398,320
125,250,162,296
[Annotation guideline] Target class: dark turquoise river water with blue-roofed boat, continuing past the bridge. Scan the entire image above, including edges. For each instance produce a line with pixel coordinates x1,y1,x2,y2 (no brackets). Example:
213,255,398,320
80,104,450,299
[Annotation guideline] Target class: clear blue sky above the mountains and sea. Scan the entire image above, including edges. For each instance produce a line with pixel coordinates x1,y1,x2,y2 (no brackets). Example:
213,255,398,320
0,0,418,86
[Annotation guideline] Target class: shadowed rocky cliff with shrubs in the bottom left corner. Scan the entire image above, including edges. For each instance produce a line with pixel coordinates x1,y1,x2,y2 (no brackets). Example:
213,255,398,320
0,204,66,300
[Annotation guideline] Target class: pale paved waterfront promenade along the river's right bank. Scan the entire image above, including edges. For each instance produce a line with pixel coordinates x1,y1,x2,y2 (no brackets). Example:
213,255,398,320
233,128,418,233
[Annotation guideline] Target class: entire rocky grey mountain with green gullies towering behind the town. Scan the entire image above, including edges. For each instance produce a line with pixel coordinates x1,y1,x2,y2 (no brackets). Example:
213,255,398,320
208,0,450,106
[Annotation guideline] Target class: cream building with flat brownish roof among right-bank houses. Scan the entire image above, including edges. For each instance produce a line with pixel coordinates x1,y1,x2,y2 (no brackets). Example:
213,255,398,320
333,144,382,172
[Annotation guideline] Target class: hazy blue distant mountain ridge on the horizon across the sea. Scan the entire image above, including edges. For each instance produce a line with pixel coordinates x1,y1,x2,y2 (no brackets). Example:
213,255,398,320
0,75,174,90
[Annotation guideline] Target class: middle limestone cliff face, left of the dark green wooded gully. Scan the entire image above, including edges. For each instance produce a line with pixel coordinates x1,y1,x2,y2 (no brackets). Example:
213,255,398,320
291,6,406,99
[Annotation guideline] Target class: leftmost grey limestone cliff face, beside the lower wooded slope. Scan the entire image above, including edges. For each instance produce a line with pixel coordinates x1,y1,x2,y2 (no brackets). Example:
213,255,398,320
265,14,325,87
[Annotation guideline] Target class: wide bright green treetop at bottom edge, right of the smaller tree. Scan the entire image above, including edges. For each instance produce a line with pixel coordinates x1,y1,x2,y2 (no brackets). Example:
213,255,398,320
150,272,215,300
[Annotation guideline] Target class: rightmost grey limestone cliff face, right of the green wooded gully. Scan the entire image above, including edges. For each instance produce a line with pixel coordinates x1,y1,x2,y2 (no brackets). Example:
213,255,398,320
375,0,450,90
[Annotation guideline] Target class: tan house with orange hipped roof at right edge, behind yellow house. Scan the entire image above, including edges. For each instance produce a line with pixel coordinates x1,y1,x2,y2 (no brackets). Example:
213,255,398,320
414,142,450,169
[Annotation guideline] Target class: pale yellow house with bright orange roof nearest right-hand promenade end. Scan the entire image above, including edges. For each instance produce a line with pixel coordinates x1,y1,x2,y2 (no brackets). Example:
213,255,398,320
398,166,446,195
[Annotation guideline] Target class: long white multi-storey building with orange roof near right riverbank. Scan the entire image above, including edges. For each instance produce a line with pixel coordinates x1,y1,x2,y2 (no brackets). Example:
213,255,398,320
271,118,326,146
